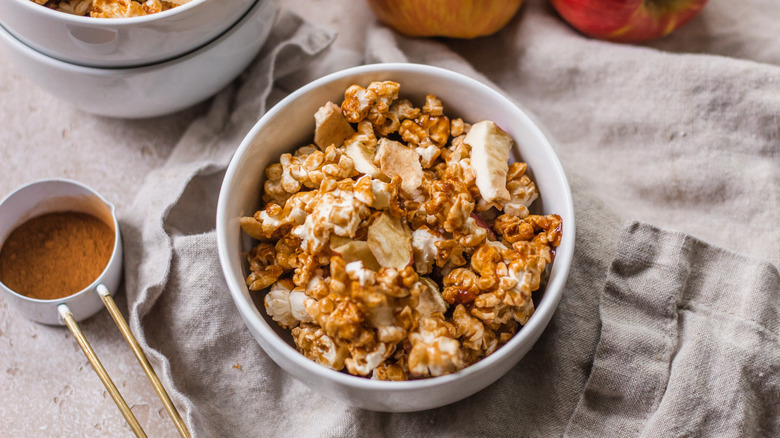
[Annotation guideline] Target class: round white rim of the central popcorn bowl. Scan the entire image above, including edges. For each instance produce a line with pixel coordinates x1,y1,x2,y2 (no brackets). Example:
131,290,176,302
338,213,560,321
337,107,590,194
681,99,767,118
216,63,575,392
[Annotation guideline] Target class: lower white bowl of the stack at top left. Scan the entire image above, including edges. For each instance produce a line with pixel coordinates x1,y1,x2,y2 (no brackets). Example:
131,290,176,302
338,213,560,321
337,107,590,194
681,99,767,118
0,0,278,118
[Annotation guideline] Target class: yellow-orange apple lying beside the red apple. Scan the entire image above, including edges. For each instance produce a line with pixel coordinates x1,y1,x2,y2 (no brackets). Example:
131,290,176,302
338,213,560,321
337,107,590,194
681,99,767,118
367,0,523,39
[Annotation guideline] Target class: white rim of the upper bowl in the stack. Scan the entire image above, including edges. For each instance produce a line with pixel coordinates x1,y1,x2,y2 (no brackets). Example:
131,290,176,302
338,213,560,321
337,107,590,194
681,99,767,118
0,0,269,76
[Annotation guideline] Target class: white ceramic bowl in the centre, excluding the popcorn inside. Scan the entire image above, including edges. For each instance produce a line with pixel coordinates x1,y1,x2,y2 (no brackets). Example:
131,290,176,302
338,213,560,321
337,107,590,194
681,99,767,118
217,64,574,412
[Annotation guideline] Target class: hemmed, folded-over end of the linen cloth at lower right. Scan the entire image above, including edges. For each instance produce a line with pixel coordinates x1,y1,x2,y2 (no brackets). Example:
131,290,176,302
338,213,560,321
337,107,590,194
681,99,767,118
566,222,780,437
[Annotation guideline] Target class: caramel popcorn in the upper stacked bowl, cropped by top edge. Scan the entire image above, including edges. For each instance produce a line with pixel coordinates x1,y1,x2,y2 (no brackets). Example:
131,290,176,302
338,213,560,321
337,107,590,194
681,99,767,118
32,0,190,18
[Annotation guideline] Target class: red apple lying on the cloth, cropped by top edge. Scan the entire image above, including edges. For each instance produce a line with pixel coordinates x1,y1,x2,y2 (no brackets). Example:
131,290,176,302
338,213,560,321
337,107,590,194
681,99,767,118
550,0,707,43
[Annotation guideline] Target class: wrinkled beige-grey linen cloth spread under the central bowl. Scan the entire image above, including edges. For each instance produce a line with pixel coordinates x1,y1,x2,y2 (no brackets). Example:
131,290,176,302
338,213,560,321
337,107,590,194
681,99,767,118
121,0,780,437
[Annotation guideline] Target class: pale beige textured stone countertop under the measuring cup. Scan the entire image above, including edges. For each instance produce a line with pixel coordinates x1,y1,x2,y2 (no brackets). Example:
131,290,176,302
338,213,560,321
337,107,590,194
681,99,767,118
0,0,360,437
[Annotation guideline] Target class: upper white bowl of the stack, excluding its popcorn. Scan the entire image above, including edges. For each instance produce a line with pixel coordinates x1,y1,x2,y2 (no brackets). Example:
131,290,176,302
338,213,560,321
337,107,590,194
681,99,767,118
0,0,255,67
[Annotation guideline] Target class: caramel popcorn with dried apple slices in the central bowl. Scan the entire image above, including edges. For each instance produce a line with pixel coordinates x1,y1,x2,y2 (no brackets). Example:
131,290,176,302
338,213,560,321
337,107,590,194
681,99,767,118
241,81,561,380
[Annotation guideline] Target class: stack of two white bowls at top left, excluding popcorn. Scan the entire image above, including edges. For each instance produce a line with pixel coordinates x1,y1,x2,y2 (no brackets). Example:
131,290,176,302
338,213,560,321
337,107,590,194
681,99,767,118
0,0,278,118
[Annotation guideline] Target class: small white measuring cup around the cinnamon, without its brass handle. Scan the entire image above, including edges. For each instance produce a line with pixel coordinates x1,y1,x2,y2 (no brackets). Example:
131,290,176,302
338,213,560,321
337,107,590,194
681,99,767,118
0,179,122,325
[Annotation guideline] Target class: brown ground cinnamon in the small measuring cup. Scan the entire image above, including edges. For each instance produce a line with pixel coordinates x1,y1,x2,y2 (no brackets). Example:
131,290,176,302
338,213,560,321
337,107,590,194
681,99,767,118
0,212,114,300
